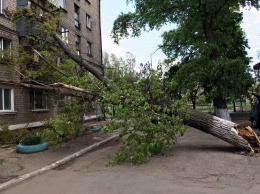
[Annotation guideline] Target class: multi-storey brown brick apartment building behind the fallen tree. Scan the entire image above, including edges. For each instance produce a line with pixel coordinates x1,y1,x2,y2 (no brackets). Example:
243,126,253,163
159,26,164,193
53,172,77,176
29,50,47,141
0,0,102,129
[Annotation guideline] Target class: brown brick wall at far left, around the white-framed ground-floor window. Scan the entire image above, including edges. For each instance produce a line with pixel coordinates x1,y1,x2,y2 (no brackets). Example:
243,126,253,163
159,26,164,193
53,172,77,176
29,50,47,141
0,0,57,125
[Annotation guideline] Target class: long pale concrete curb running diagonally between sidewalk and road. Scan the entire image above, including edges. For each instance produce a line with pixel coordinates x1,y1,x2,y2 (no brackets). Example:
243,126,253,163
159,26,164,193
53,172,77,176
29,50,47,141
0,134,118,191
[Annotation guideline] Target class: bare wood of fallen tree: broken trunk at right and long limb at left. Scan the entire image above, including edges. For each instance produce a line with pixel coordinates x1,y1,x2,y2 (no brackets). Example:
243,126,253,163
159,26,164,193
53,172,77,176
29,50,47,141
51,34,260,152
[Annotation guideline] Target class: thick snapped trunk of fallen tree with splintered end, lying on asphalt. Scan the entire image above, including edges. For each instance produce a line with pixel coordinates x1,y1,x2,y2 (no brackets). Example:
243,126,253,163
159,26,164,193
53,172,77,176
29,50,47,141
187,109,260,153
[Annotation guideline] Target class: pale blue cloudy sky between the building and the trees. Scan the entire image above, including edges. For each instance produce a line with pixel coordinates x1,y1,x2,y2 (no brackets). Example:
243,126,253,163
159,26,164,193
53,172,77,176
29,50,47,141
101,0,260,69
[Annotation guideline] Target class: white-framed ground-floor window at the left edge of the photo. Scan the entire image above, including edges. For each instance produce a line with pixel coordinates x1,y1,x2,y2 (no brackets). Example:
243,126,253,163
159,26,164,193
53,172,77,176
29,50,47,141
0,88,14,112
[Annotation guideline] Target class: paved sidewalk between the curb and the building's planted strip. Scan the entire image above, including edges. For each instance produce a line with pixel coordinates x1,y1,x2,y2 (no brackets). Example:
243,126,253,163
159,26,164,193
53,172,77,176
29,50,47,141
0,121,116,191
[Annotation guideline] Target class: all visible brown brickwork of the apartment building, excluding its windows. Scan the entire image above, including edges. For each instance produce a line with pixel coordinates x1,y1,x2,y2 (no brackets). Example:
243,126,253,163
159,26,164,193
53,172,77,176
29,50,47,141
0,0,102,125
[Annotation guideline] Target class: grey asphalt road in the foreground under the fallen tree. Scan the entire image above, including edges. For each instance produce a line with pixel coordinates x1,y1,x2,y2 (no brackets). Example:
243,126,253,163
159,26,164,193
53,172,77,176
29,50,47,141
2,128,260,194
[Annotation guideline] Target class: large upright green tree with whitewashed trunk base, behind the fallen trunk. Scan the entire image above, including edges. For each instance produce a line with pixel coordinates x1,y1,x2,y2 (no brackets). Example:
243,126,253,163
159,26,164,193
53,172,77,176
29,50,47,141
113,0,259,120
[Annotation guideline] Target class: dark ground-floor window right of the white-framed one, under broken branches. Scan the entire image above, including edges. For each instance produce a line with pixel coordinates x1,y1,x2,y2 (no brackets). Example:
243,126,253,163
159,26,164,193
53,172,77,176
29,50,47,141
30,90,47,110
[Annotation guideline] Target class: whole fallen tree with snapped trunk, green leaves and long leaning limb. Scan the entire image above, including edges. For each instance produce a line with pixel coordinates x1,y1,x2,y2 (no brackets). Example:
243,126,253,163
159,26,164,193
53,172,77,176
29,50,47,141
7,4,260,163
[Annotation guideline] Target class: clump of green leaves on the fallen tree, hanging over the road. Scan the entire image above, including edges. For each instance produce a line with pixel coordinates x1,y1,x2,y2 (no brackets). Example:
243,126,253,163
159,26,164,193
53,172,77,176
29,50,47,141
102,63,187,165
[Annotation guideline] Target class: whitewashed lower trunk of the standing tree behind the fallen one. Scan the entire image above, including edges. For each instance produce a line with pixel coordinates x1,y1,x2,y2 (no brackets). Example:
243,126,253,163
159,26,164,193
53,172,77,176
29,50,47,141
213,97,231,121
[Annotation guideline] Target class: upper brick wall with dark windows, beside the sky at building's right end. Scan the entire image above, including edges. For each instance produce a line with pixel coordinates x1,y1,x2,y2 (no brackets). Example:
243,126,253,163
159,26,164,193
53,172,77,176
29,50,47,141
61,0,102,64
